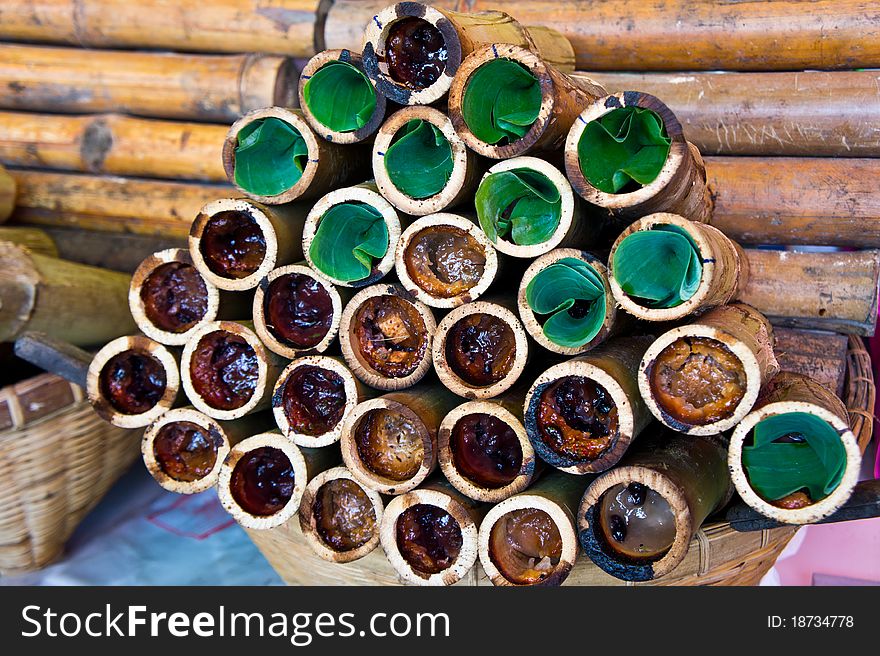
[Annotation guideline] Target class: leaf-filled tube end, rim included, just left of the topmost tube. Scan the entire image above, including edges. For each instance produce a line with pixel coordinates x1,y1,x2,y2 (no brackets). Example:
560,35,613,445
298,49,386,144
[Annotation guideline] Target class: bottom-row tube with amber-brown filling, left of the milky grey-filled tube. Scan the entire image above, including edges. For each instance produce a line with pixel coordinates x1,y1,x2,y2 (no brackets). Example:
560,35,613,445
479,472,587,586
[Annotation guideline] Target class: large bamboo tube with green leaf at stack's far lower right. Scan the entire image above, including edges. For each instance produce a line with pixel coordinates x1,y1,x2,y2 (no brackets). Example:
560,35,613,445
727,373,861,524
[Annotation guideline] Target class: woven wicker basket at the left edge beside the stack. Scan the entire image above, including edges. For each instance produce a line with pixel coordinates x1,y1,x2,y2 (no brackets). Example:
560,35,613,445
0,374,140,574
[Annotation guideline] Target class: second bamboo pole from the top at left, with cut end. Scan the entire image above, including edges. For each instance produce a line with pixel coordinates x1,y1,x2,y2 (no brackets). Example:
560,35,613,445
0,44,299,123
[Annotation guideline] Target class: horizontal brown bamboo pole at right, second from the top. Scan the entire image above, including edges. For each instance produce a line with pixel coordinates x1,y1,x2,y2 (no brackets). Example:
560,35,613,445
573,71,880,160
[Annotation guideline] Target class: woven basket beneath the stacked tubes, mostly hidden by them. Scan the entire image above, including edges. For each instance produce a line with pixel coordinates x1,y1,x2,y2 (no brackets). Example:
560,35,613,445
248,336,875,585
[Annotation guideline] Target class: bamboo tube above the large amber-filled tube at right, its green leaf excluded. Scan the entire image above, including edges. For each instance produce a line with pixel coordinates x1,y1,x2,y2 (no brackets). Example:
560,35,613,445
608,213,749,321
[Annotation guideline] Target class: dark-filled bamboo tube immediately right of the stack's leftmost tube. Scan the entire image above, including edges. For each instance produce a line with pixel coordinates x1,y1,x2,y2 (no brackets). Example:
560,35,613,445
180,321,284,420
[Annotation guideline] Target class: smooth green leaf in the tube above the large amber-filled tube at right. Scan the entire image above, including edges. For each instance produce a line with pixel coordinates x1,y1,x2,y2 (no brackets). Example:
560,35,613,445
611,225,703,308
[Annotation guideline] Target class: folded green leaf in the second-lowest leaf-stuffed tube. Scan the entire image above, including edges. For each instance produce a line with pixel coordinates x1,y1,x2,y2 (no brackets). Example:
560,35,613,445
526,257,606,348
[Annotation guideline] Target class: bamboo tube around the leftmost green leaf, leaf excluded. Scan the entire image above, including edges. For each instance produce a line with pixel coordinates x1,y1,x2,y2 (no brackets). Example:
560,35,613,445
222,107,367,205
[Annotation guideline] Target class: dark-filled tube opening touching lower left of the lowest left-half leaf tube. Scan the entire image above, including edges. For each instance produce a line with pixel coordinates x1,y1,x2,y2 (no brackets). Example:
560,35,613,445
253,264,342,359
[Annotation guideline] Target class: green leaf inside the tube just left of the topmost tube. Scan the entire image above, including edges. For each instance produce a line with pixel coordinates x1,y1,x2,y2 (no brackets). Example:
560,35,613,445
303,61,376,132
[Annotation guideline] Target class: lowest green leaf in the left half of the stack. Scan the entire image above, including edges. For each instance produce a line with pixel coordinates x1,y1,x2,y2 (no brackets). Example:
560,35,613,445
309,202,389,282
